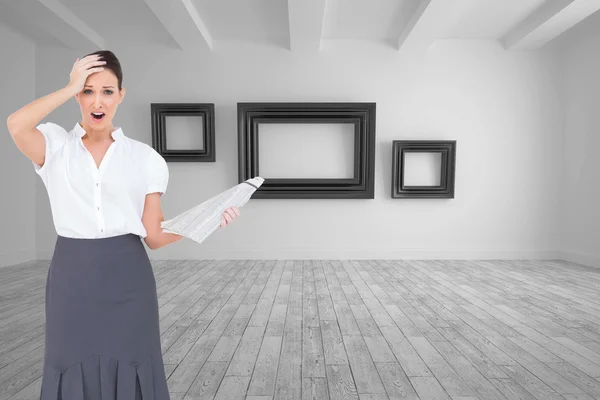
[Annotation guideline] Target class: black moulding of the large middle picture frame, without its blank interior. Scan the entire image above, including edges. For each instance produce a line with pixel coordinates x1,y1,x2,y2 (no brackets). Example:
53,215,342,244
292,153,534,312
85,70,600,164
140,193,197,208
237,102,376,199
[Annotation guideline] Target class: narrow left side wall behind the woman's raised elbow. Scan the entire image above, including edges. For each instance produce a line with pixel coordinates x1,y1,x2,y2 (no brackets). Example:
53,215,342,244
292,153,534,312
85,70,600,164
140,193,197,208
0,24,36,266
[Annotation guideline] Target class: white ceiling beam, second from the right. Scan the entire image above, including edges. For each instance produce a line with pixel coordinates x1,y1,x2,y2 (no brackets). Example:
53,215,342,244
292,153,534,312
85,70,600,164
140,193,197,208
398,0,469,50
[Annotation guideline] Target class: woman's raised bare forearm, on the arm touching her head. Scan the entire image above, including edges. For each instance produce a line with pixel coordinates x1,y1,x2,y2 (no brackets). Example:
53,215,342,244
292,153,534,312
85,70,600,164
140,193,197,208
6,86,76,135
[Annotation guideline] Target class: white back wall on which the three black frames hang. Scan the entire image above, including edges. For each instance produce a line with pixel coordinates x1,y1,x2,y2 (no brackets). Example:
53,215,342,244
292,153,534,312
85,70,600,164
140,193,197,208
31,41,562,259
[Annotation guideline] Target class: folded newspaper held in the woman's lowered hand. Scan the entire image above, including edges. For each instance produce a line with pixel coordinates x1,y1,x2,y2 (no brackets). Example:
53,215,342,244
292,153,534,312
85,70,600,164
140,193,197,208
161,176,265,243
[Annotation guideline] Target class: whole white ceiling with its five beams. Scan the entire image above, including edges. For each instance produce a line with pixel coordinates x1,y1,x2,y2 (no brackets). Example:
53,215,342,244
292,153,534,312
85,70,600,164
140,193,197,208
0,0,600,51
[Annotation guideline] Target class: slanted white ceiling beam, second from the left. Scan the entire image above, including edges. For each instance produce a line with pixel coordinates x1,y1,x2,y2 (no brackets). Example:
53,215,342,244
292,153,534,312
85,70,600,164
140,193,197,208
144,0,213,52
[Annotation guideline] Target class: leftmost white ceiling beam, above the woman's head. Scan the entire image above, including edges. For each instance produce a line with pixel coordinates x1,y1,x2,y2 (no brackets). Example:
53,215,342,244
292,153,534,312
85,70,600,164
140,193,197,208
4,0,106,51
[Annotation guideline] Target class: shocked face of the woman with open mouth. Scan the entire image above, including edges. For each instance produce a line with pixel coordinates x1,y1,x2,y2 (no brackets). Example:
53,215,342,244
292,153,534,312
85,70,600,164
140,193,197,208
75,69,125,131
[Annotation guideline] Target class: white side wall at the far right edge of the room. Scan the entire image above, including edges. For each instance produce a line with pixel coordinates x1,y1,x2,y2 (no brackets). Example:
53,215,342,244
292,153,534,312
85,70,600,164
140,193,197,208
556,13,600,267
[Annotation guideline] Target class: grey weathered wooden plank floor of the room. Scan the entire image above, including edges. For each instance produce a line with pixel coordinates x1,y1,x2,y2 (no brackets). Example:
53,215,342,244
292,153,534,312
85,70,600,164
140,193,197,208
0,260,600,400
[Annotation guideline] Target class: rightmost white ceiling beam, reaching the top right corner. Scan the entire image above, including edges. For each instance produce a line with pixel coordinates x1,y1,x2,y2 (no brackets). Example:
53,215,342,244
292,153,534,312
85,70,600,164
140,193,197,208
501,0,600,50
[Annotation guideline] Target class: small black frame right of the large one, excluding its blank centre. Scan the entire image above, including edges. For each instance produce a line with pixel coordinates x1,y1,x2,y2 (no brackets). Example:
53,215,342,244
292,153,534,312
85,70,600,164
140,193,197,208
392,140,456,199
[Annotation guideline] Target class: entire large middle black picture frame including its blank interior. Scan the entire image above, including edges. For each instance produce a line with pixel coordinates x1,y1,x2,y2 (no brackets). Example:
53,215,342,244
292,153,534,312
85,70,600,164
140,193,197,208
238,103,375,199
